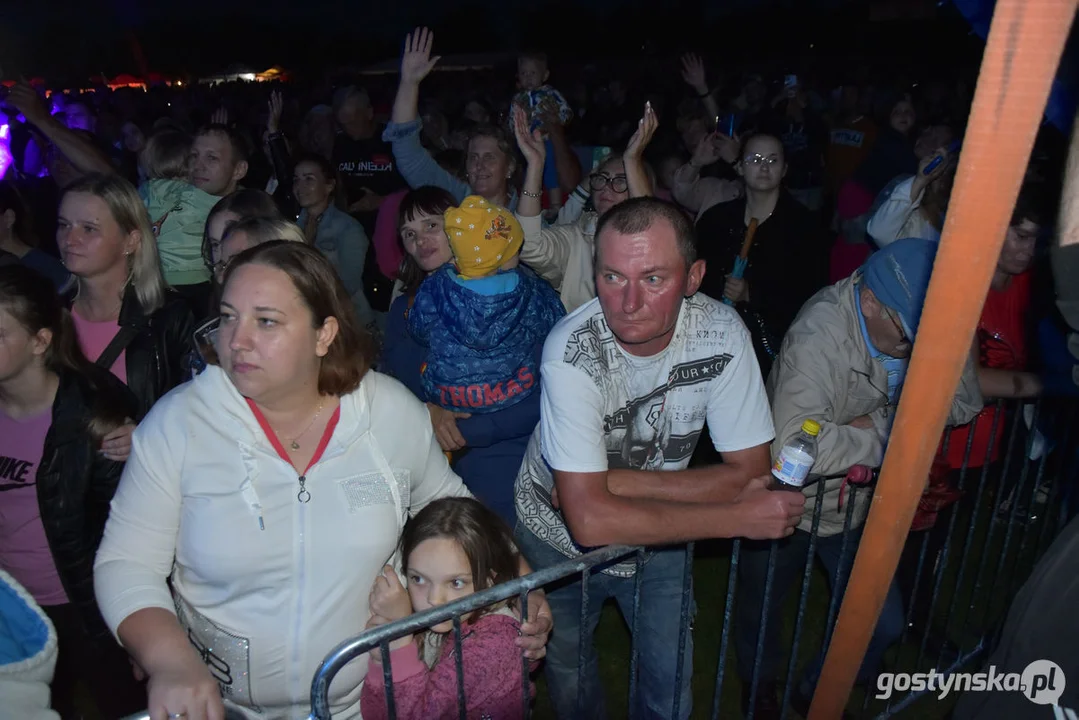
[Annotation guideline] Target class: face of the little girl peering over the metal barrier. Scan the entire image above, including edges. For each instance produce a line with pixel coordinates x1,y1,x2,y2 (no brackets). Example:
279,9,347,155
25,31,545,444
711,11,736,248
408,538,476,633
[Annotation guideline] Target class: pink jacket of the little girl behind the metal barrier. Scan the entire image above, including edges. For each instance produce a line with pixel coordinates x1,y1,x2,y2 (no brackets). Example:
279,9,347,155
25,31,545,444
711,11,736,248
360,615,522,720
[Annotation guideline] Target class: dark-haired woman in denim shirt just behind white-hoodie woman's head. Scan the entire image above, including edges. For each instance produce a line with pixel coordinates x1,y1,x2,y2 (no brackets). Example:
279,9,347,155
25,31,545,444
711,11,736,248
292,154,374,326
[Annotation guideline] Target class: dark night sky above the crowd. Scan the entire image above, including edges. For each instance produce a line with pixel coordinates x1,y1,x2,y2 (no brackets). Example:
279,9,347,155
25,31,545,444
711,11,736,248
0,0,965,79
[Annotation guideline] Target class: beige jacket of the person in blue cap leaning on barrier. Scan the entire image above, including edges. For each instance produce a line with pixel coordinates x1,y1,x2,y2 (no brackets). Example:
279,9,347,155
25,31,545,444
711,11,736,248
766,273,982,536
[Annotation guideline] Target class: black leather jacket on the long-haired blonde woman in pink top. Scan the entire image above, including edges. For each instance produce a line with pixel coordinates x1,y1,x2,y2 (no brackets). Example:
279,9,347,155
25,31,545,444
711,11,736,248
71,285,195,418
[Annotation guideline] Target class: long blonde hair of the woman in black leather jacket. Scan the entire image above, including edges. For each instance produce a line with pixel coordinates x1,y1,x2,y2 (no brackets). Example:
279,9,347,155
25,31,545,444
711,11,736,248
64,173,168,315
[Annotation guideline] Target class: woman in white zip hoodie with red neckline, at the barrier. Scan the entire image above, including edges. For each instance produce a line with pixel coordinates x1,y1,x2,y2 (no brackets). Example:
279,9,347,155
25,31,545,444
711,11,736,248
94,242,550,720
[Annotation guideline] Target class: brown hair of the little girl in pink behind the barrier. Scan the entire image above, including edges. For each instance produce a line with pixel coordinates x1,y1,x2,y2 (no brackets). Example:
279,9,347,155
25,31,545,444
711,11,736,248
401,498,520,623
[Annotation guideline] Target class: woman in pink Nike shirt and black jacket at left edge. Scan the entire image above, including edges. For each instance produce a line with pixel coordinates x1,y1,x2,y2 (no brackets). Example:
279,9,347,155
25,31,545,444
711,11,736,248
0,266,146,719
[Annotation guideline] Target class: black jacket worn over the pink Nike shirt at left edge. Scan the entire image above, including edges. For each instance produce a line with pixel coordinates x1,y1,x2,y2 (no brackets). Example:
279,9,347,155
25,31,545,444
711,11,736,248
37,368,140,639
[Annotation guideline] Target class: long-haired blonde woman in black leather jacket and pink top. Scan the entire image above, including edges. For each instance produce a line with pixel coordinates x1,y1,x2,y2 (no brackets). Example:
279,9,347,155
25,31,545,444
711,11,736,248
56,175,194,425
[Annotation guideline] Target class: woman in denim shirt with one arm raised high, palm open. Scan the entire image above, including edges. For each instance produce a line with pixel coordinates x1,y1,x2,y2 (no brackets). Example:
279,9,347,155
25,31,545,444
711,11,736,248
382,28,517,210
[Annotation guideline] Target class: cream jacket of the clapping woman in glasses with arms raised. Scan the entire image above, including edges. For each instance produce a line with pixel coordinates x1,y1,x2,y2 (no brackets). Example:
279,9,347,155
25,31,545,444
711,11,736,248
517,213,599,313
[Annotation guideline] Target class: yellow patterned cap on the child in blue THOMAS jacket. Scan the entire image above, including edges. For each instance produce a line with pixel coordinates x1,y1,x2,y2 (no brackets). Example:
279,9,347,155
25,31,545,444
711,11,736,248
442,195,524,277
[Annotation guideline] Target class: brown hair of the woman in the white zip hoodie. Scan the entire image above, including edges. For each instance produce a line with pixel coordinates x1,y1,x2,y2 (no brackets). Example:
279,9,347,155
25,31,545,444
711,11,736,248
222,240,374,395
